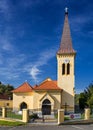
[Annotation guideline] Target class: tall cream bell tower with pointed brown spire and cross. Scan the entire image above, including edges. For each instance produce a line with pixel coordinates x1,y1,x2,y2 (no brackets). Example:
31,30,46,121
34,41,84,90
57,8,76,112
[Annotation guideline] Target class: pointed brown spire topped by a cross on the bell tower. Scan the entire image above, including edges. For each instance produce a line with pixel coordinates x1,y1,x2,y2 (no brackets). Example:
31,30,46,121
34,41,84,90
57,7,75,54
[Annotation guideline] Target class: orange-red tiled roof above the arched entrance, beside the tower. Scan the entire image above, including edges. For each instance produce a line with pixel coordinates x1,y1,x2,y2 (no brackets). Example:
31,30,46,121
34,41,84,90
34,79,62,90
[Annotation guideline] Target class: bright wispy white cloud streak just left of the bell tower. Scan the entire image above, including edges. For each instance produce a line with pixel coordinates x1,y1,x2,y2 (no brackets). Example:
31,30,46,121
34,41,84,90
29,48,56,83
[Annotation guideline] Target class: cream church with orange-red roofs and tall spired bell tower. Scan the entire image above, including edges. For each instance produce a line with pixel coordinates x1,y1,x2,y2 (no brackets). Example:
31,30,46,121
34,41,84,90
13,8,76,115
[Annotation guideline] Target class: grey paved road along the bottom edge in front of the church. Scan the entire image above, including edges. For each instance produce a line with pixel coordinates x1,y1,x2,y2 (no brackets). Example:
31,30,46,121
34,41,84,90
0,125,93,130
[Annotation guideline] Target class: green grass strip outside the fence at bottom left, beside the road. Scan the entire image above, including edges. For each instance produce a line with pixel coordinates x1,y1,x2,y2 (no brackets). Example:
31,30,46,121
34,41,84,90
0,120,26,126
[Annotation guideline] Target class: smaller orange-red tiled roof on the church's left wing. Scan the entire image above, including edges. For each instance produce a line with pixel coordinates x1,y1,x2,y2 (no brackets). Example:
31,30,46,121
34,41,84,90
12,82,33,93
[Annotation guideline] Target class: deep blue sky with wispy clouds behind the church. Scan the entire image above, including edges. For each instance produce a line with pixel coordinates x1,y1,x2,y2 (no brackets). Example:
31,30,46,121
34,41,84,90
0,0,93,93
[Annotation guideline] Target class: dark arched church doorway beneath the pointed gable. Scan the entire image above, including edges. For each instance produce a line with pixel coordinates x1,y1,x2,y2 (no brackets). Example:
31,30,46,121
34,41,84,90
42,99,51,115
